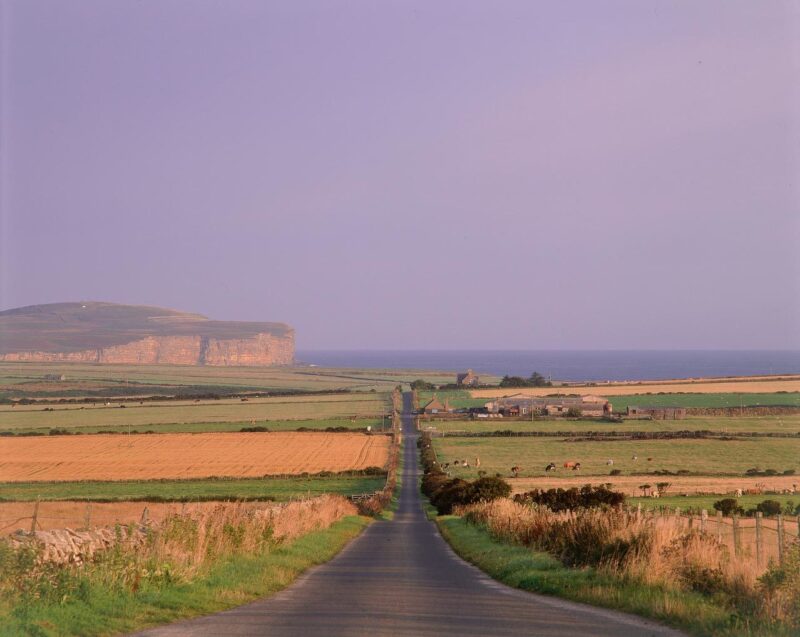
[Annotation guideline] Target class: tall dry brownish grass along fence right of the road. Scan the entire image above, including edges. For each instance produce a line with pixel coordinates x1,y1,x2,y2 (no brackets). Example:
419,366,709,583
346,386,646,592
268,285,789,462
456,499,800,627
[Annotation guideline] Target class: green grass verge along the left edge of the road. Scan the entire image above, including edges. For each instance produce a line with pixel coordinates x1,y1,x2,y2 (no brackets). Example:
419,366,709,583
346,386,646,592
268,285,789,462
0,516,371,637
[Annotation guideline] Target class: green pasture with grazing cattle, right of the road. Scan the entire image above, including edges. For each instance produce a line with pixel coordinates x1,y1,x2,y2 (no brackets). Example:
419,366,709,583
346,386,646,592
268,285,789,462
433,437,800,478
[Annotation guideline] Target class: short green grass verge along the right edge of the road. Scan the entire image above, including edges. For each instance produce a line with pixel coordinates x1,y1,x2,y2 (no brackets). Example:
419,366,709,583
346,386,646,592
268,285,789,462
436,516,792,637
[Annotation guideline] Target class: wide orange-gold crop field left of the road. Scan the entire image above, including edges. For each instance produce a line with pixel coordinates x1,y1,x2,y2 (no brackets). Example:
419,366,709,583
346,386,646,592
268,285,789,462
0,432,389,482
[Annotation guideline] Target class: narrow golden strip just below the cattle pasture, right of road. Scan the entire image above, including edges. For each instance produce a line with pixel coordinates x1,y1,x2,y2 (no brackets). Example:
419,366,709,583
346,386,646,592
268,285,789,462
507,475,800,497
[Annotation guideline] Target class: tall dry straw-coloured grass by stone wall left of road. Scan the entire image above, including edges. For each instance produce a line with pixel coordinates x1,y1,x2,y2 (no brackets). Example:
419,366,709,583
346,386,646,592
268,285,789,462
0,496,356,624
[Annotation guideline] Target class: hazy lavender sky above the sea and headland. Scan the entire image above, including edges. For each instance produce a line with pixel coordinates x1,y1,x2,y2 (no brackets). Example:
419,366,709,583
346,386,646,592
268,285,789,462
0,0,800,349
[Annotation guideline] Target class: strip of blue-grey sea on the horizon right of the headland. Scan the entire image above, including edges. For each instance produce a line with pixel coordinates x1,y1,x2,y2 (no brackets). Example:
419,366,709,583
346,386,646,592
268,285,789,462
297,350,800,382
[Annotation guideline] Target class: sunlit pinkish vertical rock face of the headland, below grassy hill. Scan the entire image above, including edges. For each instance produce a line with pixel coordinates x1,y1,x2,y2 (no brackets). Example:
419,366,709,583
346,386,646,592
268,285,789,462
0,333,294,366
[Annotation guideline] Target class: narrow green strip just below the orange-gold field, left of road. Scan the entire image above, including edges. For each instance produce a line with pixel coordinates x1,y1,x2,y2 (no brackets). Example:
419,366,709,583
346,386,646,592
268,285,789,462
0,475,386,501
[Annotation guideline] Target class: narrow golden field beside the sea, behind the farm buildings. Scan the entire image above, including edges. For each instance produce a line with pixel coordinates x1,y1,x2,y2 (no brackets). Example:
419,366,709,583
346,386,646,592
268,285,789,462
470,377,800,398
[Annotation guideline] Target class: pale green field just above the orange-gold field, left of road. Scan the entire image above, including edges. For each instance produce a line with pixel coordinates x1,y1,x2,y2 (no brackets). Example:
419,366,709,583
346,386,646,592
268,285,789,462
0,392,392,431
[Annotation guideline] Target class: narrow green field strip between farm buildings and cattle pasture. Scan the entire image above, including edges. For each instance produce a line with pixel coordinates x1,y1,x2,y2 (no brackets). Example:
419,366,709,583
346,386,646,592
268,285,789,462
428,414,800,434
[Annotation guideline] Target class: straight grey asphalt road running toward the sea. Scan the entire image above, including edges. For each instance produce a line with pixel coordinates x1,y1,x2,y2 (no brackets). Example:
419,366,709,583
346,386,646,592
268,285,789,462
138,395,682,637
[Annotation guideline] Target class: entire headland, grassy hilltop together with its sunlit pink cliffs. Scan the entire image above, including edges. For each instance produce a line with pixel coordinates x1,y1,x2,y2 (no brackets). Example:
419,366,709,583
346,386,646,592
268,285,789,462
0,302,294,366
